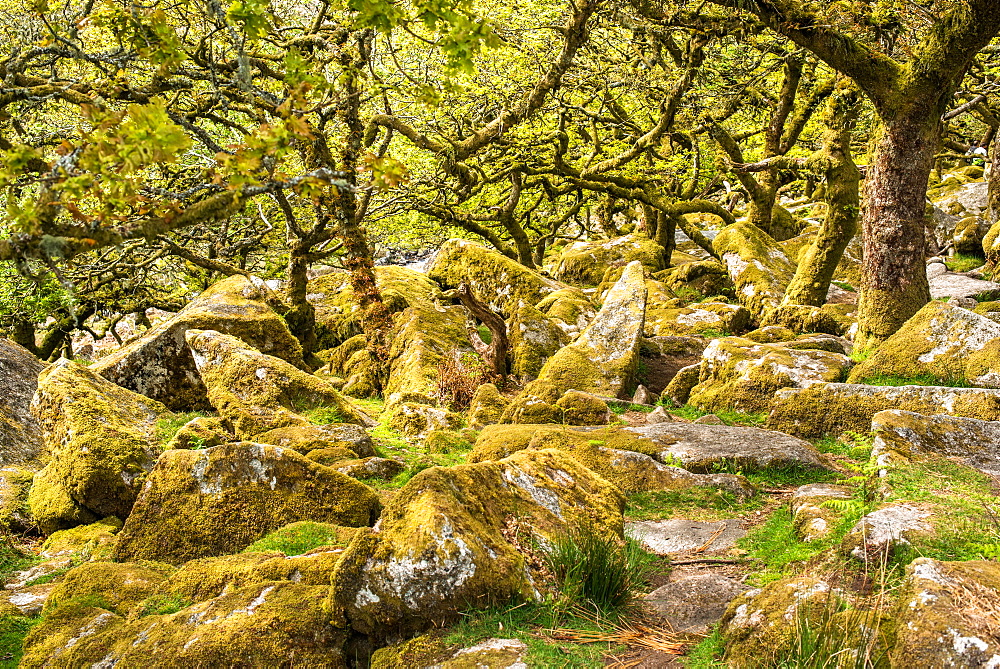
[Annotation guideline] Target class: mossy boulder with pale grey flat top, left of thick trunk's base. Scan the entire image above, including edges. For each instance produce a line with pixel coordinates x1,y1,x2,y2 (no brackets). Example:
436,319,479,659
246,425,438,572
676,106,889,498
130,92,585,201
687,337,853,413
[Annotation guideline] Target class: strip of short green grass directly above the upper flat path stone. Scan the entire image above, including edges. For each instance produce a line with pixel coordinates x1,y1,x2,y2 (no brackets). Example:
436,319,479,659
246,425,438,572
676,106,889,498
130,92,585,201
625,487,764,521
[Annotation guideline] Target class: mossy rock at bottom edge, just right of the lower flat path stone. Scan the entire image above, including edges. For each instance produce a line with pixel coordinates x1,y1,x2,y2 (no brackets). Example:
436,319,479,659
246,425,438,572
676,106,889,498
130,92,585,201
719,577,843,669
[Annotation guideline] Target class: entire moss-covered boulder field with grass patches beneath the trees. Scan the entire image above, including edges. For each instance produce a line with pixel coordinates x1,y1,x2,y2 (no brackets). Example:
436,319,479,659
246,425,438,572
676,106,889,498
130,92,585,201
0,168,1000,668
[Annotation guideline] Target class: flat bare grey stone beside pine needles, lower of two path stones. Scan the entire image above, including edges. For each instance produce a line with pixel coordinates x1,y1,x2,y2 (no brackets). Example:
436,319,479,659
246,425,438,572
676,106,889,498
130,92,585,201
644,574,749,634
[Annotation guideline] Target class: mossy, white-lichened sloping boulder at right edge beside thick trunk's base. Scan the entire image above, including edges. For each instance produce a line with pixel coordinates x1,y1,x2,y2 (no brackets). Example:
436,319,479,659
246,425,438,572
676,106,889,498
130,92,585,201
848,301,1000,388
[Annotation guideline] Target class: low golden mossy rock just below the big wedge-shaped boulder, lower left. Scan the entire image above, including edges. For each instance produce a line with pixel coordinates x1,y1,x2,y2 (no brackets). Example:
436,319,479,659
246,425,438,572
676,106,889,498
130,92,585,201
45,562,176,615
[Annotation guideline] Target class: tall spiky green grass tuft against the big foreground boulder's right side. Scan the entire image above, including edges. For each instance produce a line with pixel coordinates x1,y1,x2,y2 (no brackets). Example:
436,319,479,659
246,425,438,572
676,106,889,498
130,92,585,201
545,525,652,615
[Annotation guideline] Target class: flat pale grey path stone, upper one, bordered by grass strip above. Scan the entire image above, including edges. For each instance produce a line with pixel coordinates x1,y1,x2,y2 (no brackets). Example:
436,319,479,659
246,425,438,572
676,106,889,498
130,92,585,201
625,518,746,555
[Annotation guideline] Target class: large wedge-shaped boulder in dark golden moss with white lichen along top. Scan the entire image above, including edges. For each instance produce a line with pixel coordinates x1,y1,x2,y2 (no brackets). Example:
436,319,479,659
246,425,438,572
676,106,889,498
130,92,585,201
115,443,380,564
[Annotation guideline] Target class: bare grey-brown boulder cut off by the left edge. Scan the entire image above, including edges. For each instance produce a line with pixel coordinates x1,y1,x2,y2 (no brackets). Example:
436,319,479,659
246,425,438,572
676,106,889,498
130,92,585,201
0,337,45,466
